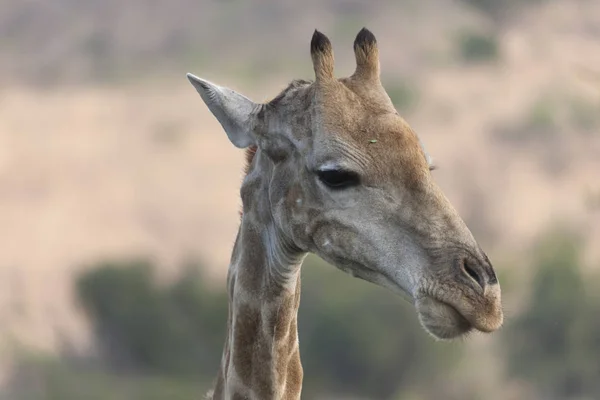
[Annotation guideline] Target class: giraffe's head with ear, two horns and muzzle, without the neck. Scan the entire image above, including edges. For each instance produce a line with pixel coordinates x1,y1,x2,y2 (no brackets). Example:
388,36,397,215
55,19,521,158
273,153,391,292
188,29,503,339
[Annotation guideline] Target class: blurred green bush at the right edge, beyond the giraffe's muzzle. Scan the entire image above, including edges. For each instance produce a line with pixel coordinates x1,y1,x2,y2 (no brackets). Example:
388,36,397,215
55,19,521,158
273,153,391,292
505,232,600,399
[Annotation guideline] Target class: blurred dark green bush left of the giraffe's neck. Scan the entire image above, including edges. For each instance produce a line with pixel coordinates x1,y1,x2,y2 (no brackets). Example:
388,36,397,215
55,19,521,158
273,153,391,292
77,260,227,375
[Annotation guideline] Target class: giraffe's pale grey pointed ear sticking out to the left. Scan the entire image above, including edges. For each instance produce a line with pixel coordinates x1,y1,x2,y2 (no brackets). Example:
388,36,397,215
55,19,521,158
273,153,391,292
187,74,258,148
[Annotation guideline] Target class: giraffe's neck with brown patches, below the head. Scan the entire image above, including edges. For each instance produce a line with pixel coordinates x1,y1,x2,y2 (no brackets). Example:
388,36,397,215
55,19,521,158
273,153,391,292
213,213,303,400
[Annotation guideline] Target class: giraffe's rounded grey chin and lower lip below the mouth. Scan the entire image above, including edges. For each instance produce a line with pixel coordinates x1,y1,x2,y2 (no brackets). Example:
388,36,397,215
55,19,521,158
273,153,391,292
415,296,475,340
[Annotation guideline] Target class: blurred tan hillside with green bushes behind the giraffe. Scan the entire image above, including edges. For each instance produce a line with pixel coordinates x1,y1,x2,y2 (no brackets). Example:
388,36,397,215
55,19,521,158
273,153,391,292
0,0,600,400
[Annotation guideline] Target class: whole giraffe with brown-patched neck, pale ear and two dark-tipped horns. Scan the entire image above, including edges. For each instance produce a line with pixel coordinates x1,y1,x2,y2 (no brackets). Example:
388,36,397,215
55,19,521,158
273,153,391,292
187,28,503,400
